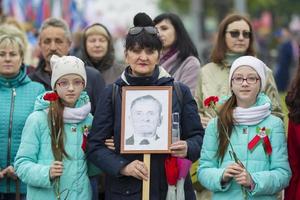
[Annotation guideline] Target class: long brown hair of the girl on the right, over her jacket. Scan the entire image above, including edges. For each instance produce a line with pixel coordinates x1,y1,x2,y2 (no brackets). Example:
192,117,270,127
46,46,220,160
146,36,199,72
216,94,236,161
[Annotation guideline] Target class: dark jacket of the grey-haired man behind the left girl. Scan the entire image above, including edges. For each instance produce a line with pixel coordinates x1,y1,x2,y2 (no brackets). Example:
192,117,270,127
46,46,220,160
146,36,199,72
28,60,105,114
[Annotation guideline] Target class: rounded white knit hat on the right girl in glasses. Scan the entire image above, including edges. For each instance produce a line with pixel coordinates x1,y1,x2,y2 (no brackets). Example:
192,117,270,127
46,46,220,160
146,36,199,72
229,56,267,90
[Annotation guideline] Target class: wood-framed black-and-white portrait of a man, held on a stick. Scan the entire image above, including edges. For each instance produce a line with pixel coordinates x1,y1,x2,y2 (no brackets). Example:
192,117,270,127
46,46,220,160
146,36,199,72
121,86,172,154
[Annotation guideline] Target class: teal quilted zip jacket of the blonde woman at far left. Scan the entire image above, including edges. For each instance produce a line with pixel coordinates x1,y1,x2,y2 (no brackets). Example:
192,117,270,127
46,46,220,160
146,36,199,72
0,66,44,194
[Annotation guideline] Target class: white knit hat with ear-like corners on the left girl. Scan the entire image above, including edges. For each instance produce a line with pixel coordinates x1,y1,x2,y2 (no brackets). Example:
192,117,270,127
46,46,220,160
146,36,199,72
50,55,87,89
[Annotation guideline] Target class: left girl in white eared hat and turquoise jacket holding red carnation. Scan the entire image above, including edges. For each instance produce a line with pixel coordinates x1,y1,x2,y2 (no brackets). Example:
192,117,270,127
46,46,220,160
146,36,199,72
15,55,92,200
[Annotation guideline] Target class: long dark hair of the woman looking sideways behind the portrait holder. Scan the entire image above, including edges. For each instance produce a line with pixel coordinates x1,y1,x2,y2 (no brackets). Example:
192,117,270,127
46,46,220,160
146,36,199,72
153,13,199,61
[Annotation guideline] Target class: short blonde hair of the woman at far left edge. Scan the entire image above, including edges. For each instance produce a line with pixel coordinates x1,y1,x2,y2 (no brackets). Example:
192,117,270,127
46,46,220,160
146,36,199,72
0,34,24,59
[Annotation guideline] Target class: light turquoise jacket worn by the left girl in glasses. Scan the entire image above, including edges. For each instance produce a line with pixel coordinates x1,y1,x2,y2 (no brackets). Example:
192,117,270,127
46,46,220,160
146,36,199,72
15,92,92,200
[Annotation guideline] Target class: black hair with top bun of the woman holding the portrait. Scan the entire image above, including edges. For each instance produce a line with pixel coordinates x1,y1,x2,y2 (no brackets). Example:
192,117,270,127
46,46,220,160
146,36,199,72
125,13,162,52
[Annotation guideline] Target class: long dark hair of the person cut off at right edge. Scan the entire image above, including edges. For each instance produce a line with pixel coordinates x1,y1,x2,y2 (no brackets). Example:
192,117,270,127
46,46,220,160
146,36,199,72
285,56,300,124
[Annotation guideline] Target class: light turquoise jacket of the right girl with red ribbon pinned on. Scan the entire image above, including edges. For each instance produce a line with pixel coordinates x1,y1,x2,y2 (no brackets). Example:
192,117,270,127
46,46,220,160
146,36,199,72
198,94,291,200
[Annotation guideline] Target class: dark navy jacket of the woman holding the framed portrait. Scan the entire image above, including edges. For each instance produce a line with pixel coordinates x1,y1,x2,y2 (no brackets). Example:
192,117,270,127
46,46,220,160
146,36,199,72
88,67,203,200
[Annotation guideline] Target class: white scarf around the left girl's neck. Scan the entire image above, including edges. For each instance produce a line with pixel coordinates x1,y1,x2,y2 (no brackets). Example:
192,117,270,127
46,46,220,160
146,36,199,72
64,102,91,124
